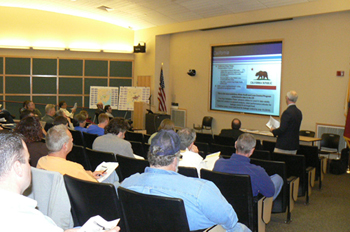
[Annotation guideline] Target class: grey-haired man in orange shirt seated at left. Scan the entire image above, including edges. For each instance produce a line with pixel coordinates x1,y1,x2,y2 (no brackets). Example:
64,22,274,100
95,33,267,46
37,125,119,187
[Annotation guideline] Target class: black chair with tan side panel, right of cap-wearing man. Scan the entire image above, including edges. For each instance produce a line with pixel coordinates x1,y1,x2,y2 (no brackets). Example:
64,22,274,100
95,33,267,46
201,169,272,232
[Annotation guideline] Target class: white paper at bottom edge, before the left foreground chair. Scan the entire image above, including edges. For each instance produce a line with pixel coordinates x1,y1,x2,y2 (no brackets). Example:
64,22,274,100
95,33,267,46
78,215,120,232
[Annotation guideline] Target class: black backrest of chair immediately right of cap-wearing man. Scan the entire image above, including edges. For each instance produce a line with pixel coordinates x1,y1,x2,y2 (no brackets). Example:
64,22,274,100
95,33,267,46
201,169,257,231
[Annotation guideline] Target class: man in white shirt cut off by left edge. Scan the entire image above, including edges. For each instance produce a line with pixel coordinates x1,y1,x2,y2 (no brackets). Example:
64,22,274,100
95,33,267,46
0,132,120,232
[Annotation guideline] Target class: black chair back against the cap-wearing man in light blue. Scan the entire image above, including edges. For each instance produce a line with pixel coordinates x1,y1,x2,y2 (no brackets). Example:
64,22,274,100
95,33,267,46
118,187,190,232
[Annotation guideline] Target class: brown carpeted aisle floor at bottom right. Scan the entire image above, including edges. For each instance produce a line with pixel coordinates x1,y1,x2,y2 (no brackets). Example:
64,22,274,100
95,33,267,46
266,174,350,232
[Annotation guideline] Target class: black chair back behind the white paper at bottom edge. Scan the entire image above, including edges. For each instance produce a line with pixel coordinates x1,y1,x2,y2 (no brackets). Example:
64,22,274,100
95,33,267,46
63,175,129,231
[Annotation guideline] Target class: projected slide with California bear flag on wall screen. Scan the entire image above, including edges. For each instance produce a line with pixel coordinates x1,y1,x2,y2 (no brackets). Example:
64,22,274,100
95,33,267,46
211,42,282,116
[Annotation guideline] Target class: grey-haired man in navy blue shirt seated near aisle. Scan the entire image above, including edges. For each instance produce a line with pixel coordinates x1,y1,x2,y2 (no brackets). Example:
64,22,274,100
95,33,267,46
213,133,283,199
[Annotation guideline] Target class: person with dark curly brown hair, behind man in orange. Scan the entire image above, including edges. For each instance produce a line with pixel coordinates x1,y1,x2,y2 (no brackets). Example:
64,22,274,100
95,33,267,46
14,116,49,167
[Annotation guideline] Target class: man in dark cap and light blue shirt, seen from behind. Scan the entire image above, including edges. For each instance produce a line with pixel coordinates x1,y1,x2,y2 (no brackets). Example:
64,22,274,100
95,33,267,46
121,130,250,232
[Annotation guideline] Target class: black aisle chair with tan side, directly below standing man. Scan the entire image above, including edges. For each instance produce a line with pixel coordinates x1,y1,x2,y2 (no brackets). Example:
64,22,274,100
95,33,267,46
271,152,316,205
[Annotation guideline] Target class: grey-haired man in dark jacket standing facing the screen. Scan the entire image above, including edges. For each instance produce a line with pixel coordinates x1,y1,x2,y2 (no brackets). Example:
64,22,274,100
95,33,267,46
271,91,303,154
